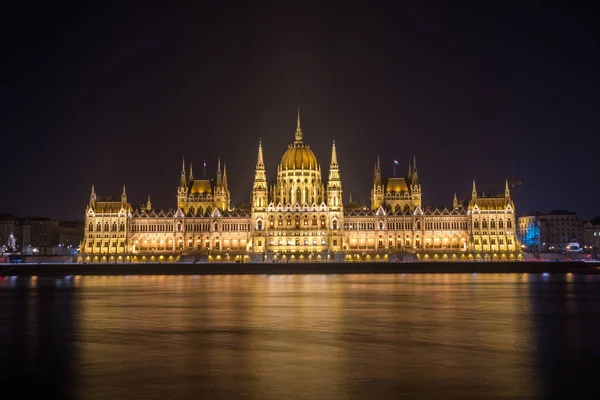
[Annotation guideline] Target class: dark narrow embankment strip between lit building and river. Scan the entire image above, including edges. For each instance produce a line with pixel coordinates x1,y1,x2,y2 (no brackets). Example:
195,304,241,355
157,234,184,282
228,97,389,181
0,261,600,277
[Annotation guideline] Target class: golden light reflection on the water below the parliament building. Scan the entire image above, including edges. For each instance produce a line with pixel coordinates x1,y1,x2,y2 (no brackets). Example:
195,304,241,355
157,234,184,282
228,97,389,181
59,274,544,399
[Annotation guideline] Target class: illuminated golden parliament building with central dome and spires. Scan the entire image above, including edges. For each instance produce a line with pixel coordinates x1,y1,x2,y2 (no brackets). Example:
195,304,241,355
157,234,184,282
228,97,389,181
78,113,521,263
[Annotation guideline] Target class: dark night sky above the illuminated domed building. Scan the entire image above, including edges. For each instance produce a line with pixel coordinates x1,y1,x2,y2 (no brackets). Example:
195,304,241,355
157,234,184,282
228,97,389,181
0,0,600,218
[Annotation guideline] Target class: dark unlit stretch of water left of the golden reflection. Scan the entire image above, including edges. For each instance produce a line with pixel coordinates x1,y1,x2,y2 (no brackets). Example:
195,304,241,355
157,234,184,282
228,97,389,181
0,277,77,398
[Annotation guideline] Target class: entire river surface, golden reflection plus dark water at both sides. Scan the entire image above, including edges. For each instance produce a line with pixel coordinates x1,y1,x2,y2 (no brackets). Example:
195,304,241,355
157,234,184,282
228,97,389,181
0,274,600,400
